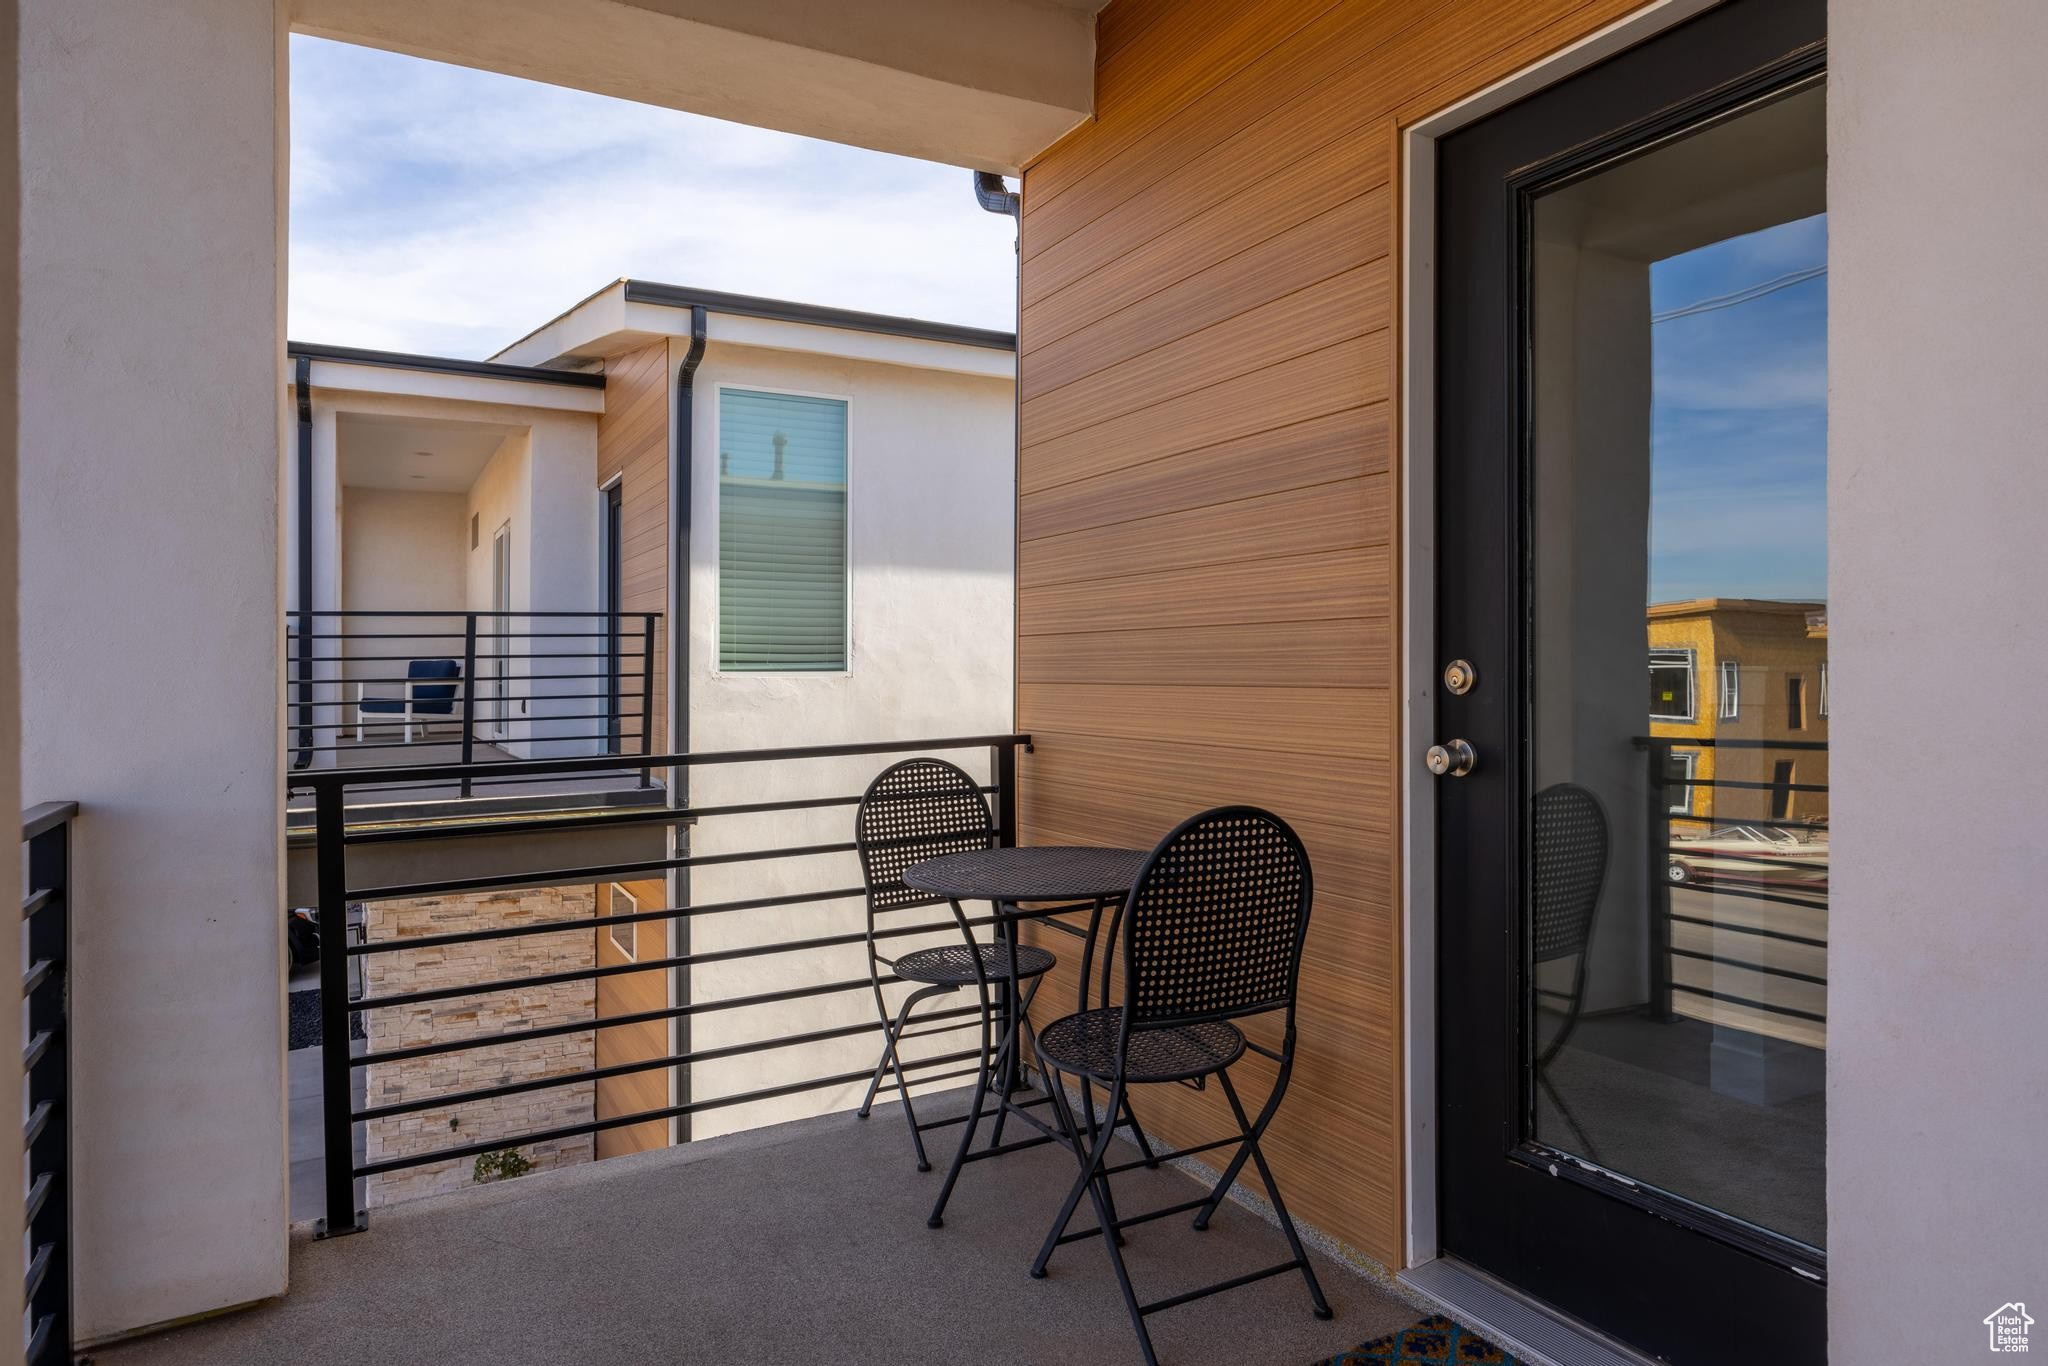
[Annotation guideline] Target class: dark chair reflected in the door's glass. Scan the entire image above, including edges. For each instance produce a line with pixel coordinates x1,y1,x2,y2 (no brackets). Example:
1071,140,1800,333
1530,782,1608,1161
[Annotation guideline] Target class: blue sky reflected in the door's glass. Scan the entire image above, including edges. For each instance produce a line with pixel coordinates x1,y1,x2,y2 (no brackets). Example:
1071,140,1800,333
1651,215,1827,602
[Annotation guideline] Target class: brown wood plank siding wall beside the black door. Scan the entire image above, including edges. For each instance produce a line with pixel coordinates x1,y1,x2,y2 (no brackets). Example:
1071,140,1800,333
1018,0,1632,1266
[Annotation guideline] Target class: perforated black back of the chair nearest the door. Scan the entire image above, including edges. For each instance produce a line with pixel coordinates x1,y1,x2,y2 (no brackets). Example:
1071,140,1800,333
1124,807,1315,1028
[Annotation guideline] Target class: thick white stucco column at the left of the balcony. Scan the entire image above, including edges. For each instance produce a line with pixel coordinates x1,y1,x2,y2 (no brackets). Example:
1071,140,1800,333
20,0,287,1339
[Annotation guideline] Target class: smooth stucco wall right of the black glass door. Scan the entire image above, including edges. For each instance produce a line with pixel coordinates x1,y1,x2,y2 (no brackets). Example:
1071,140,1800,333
1827,0,2048,1364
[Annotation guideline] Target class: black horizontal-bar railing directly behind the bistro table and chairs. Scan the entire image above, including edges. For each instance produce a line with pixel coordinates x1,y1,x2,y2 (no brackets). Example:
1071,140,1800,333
307,735,1040,1235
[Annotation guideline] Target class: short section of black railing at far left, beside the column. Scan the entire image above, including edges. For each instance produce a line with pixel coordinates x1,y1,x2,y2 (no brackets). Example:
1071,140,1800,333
20,801,78,1366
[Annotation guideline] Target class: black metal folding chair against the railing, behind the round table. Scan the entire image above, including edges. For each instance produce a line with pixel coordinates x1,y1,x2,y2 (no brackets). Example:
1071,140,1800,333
854,758,1057,1179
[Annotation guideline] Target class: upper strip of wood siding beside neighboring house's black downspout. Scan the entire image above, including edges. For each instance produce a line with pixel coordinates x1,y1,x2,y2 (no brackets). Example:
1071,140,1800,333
598,342,670,754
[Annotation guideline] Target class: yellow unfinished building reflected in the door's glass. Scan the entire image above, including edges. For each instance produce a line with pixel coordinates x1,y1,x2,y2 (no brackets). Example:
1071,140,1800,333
1649,598,1827,827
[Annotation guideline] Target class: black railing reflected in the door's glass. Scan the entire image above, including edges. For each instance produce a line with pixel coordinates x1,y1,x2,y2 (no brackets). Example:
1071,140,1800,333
1634,735,1829,1026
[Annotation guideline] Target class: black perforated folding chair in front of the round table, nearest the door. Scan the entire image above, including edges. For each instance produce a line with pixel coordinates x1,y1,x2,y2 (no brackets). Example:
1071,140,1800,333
1030,807,1331,1366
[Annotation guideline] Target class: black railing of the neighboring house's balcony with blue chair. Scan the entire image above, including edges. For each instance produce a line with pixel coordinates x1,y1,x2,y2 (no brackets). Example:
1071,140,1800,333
285,610,662,797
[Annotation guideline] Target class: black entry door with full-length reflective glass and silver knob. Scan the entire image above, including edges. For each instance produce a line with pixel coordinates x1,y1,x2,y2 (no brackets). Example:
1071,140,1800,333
1432,0,1827,1364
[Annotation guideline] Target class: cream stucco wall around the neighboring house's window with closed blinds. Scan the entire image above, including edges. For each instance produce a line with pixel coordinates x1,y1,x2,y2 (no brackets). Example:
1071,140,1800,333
670,342,1016,1137
